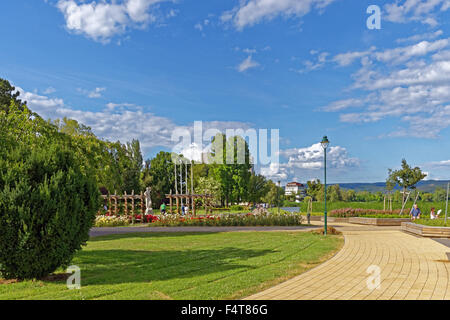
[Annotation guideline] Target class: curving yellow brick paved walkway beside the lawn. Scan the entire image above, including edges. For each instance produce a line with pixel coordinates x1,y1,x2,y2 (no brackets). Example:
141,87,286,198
247,223,450,300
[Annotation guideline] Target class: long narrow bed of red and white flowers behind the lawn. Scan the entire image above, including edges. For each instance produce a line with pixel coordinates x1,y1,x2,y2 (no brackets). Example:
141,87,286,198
150,213,303,227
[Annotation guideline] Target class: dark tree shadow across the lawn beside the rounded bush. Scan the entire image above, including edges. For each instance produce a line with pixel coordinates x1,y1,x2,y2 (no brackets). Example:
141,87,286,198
74,247,273,286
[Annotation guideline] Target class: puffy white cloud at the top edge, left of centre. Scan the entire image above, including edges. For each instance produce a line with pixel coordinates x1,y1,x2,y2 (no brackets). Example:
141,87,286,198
56,0,165,43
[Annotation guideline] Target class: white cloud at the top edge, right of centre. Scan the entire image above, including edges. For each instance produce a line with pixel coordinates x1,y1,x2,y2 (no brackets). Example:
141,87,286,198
221,0,334,30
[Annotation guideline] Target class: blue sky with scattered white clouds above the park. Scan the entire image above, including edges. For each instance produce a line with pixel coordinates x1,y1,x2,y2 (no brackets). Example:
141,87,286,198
0,0,450,182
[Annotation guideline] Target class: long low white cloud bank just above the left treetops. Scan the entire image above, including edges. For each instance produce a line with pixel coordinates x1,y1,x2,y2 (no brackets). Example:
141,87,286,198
16,86,251,153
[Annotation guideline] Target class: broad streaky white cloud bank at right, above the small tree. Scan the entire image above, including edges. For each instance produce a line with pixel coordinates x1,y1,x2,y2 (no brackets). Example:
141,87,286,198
321,32,450,138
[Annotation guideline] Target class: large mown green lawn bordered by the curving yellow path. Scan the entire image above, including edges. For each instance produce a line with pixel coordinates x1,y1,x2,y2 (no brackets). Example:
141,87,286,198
0,232,343,299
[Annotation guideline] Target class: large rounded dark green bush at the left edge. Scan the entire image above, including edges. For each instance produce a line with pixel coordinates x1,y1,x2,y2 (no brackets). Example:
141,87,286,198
0,134,100,279
